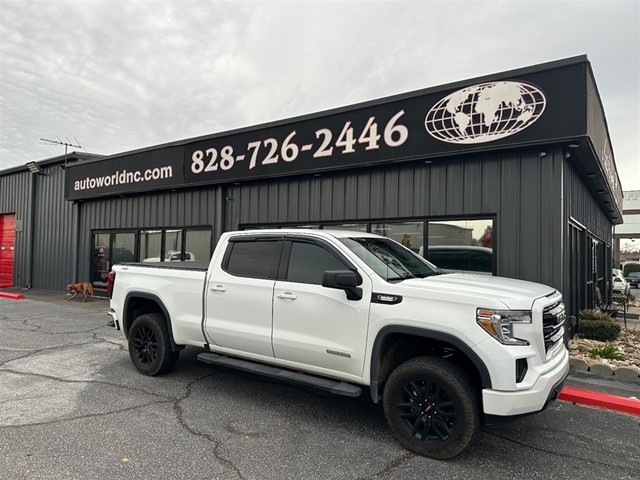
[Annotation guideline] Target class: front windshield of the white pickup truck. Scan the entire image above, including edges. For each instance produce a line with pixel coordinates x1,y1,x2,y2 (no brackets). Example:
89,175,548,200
340,237,442,282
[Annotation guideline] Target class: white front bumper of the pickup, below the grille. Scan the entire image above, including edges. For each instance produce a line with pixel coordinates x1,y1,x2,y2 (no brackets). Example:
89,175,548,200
482,349,569,417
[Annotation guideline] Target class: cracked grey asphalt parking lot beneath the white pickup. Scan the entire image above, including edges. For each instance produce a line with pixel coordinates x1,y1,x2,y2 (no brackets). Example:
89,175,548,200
0,292,640,480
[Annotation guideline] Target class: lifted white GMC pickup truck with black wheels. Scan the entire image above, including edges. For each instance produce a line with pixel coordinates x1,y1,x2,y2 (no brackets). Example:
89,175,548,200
109,229,569,458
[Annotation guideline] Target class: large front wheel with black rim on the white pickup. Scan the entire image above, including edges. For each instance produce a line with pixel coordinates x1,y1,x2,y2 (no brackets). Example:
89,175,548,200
383,357,480,459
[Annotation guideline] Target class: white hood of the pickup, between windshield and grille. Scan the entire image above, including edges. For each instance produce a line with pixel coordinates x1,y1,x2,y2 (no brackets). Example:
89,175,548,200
398,273,556,310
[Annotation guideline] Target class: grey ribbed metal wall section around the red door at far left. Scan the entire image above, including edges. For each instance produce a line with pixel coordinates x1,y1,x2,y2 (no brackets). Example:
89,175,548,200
0,171,31,286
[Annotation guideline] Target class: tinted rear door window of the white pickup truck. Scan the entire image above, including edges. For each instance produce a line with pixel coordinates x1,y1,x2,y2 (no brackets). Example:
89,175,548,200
224,240,281,279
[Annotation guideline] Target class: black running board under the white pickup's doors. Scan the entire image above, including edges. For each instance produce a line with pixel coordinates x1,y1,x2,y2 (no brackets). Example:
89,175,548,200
198,353,362,397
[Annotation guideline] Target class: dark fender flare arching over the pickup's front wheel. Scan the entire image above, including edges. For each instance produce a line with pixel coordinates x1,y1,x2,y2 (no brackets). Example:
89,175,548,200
370,325,491,403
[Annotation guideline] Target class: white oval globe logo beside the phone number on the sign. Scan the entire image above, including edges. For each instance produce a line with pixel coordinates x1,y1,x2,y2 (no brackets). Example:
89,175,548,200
424,82,546,144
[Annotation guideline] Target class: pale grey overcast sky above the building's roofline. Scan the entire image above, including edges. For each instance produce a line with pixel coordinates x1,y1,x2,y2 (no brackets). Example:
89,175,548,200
0,0,640,190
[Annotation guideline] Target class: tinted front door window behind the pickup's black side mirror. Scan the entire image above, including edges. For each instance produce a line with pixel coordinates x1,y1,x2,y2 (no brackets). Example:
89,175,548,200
286,242,348,285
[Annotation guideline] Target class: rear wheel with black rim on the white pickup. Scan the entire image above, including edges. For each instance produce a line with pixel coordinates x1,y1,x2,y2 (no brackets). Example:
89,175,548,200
129,313,180,376
